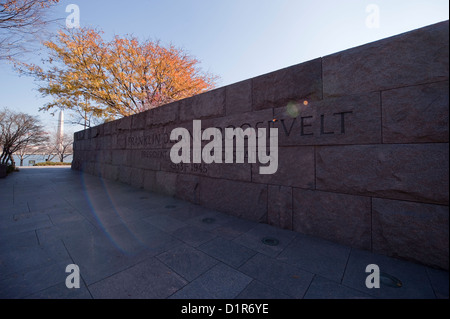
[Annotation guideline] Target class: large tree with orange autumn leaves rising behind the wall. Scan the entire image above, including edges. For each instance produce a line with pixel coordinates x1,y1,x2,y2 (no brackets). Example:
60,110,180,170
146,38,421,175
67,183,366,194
16,28,220,125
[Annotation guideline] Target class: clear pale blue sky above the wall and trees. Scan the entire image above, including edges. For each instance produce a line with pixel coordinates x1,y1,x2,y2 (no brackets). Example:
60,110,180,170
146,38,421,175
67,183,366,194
0,0,449,131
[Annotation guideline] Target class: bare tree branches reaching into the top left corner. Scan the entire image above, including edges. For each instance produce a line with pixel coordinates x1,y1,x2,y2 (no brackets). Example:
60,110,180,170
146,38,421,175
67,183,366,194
0,0,59,59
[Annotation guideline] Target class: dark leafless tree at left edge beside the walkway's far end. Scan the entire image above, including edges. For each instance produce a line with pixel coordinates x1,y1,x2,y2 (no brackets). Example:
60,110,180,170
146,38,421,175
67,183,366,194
0,108,48,166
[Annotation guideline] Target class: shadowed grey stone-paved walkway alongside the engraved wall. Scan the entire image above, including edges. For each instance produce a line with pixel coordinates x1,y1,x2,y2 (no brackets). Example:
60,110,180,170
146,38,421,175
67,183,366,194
0,167,449,299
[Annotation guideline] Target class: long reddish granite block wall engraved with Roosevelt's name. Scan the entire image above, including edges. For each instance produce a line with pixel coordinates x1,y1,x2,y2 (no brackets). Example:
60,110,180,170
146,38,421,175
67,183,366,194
72,21,449,269
